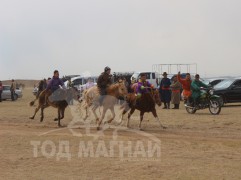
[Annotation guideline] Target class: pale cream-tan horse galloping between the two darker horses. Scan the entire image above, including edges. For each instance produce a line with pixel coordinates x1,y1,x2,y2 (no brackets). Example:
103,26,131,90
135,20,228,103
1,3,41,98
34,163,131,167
79,81,128,130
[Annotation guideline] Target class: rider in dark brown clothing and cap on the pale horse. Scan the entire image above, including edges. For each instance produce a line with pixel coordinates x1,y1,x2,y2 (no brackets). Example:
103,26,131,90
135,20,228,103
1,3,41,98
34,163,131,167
97,66,112,103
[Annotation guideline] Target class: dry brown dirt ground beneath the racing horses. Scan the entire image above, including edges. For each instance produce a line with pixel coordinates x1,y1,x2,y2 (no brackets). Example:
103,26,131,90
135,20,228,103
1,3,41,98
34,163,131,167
0,89,241,179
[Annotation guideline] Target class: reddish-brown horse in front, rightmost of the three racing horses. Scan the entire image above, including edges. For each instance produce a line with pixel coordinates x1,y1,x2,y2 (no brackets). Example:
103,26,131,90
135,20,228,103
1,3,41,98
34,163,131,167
120,89,163,130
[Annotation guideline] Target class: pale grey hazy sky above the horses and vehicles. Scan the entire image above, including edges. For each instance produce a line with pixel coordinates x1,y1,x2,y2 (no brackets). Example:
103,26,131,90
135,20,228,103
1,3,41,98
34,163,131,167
0,0,241,80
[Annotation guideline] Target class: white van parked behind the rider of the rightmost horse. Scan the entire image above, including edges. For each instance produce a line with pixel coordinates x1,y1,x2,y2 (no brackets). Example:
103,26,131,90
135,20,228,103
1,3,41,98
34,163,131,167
131,72,160,88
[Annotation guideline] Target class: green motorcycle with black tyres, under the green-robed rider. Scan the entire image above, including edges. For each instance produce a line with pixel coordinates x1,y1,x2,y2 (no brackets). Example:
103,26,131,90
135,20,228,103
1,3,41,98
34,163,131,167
185,88,222,115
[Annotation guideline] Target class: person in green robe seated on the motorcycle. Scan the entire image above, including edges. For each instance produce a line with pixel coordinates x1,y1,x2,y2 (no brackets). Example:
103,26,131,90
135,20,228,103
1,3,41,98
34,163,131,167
191,74,208,107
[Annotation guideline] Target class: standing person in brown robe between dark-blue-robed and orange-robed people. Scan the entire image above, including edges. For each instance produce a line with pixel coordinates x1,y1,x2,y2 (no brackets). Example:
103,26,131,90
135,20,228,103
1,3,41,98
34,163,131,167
170,76,182,109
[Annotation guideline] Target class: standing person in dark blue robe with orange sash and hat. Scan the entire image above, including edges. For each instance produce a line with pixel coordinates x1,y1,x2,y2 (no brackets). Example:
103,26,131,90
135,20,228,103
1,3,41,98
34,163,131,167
159,72,171,109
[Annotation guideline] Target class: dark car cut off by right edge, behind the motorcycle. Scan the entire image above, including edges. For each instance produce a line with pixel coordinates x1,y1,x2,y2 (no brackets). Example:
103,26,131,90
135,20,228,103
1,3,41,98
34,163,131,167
213,78,241,103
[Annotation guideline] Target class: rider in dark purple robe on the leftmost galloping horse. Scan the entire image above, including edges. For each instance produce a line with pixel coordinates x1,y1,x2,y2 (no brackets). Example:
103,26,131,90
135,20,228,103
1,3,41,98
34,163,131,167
45,70,64,105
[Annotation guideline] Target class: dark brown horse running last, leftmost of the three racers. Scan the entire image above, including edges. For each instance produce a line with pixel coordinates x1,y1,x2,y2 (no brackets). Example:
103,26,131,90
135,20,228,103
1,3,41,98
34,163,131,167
30,88,78,127
